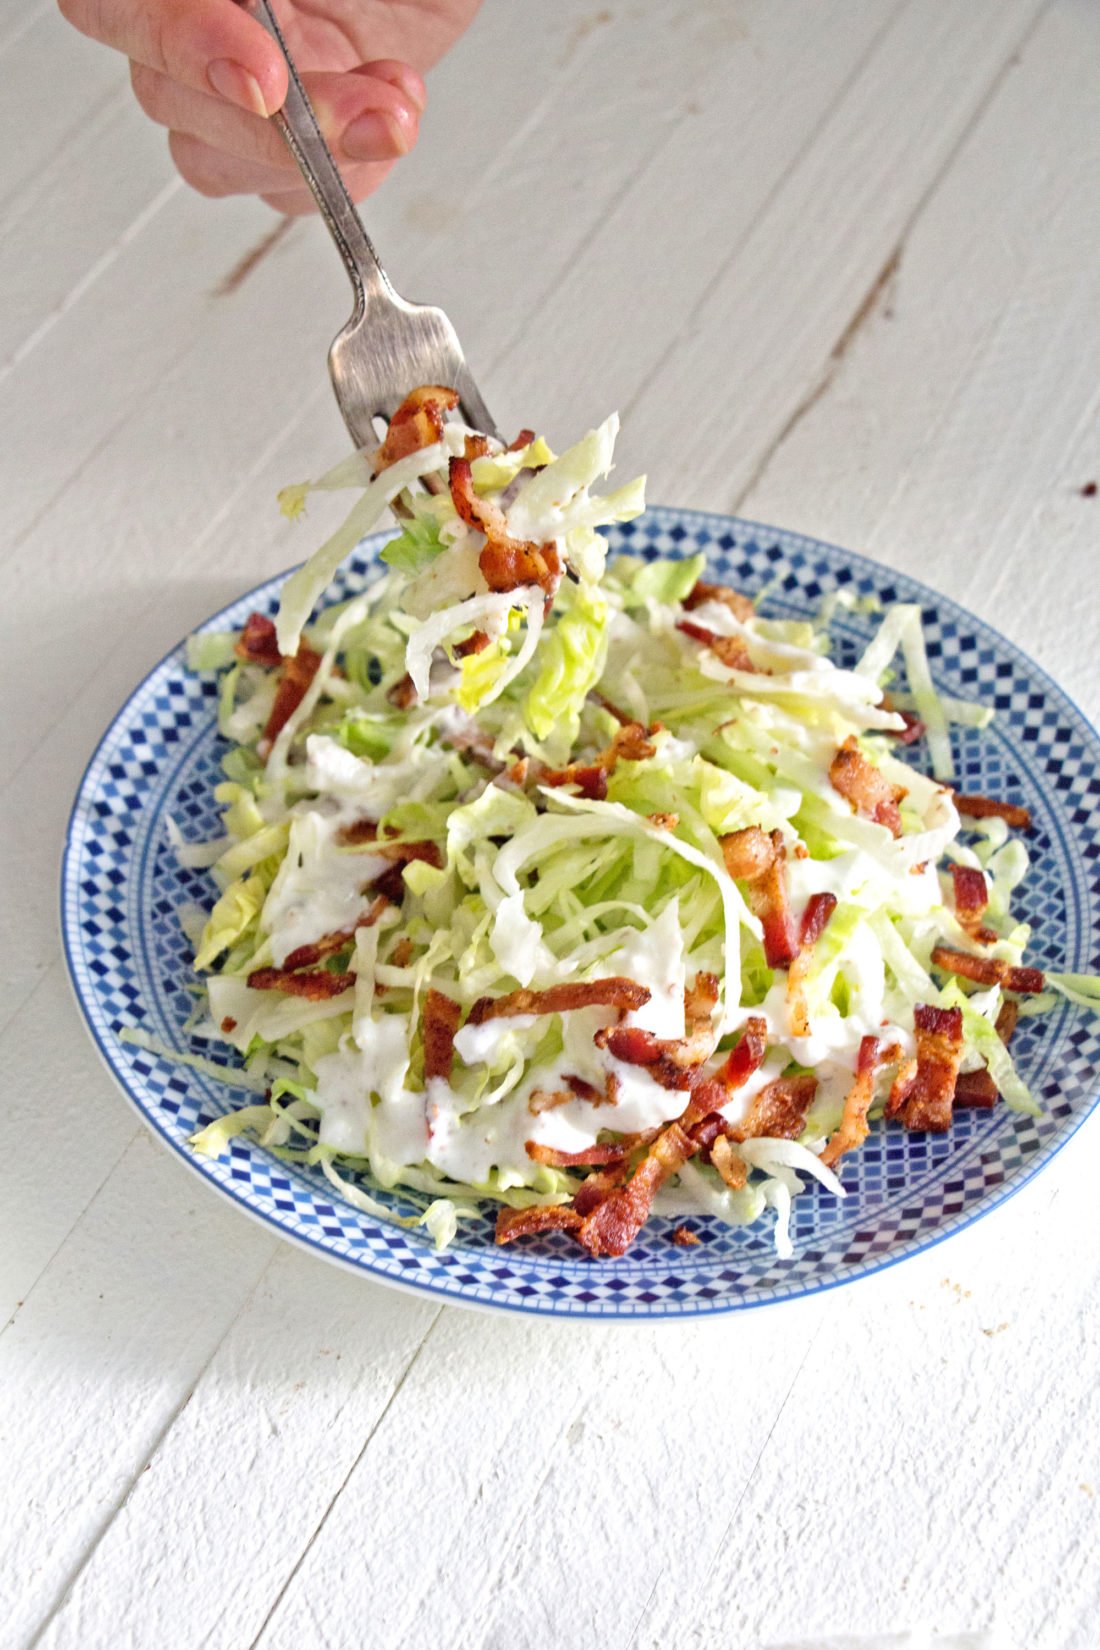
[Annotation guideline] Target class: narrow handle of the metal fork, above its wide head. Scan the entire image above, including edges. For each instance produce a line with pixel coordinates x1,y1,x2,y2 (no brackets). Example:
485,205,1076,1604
241,0,394,314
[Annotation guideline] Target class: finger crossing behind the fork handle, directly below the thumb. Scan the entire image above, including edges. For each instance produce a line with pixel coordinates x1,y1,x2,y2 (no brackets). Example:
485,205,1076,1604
130,63,419,169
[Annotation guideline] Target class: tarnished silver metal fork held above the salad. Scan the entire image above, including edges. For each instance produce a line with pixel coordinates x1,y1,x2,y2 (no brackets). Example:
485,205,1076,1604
242,0,496,447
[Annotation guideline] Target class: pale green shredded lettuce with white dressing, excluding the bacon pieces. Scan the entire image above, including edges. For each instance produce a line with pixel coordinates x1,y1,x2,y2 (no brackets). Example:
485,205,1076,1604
165,405,1100,1254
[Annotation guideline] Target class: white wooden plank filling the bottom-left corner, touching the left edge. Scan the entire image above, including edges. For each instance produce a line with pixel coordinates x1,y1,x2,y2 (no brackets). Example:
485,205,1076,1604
0,1130,275,1645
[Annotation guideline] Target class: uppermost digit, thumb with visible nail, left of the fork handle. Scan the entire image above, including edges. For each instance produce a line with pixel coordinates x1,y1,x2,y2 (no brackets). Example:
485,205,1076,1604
59,0,287,116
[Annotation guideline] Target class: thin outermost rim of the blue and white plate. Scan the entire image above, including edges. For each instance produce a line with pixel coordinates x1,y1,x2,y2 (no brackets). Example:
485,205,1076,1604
58,505,1100,1325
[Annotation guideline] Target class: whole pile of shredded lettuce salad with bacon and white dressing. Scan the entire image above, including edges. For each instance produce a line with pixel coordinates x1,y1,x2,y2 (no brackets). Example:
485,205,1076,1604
175,386,1092,1257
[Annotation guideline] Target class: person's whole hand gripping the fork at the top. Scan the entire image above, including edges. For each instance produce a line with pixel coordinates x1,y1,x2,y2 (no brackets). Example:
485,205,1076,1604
59,0,480,215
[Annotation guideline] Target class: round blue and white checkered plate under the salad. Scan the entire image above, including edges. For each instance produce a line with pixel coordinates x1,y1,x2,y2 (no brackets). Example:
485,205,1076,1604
63,508,1100,1320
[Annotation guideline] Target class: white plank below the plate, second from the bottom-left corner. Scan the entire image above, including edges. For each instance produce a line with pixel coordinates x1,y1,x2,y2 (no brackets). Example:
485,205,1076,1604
24,1247,440,1650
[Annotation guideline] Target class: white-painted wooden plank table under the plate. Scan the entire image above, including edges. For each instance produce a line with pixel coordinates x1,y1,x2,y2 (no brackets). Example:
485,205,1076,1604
0,0,1100,1650
